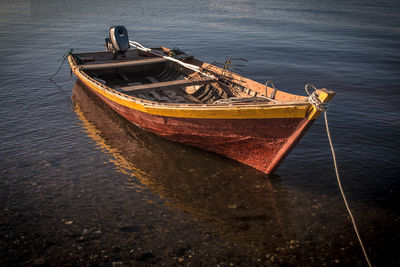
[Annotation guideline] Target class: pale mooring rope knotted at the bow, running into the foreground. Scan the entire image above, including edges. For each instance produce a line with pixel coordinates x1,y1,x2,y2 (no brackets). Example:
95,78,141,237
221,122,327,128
305,84,372,267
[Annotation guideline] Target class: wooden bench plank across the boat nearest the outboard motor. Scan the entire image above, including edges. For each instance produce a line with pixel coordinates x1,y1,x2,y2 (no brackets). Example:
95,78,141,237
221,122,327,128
79,57,169,70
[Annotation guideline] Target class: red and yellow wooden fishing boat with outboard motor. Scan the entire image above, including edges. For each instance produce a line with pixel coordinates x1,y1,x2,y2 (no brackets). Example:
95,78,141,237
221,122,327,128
68,26,335,174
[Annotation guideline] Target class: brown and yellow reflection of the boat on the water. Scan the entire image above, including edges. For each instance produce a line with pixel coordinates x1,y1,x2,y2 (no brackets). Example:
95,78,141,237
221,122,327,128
72,81,293,252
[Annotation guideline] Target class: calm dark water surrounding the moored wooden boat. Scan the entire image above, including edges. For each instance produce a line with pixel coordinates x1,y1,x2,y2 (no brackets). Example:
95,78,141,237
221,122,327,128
0,0,400,266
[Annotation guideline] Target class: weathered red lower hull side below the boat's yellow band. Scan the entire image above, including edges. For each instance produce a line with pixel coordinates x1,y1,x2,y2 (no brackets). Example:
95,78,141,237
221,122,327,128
83,81,314,174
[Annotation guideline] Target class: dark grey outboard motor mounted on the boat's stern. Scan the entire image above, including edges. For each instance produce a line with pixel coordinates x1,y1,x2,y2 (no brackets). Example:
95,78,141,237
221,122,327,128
106,26,129,58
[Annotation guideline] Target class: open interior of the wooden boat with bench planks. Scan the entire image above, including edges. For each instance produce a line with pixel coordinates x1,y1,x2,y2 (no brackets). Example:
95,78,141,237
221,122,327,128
73,48,304,104
